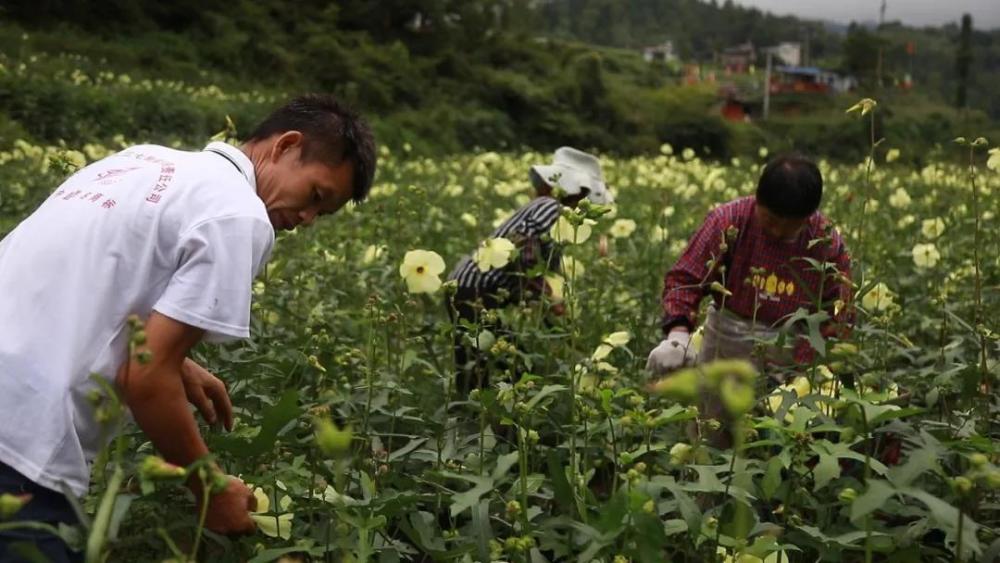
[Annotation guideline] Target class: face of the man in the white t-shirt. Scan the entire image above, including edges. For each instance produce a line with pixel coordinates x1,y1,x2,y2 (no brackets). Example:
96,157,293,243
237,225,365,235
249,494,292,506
257,131,354,230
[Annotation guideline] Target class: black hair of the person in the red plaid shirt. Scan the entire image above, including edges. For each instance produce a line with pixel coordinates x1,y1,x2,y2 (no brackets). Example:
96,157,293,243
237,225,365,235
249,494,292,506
757,154,823,219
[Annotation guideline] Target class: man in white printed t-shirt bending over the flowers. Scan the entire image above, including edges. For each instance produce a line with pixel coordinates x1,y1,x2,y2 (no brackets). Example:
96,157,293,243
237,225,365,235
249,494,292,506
0,95,375,561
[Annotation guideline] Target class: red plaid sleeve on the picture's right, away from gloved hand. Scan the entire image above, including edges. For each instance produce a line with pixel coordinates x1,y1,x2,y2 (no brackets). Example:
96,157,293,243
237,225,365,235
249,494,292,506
794,227,854,364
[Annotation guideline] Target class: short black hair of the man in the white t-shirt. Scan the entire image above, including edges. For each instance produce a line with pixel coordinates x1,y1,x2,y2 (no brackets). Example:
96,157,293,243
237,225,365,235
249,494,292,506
246,94,376,203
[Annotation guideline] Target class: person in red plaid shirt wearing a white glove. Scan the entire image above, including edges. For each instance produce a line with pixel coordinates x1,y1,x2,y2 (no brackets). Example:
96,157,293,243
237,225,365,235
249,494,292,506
646,155,852,374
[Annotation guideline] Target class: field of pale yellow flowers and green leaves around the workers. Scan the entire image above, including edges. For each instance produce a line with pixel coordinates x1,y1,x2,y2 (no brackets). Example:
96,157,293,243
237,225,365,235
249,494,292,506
0,115,1000,563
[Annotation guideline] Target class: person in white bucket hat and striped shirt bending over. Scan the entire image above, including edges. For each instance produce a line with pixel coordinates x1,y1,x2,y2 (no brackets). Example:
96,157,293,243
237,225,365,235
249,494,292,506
446,147,614,394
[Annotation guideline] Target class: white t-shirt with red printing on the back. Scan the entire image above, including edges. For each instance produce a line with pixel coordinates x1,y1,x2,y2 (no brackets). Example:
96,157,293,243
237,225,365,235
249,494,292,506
0,143,274,495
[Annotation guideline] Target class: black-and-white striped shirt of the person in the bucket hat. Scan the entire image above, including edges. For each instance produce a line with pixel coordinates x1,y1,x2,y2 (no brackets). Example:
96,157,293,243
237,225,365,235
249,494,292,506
448,196,562,301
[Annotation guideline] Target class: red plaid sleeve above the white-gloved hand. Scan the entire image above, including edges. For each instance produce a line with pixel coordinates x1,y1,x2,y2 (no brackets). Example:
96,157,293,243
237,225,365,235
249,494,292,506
661,209,729,333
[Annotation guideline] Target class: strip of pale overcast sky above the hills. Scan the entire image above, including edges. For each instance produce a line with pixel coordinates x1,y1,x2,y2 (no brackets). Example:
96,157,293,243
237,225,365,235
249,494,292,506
734,0,1000,29
